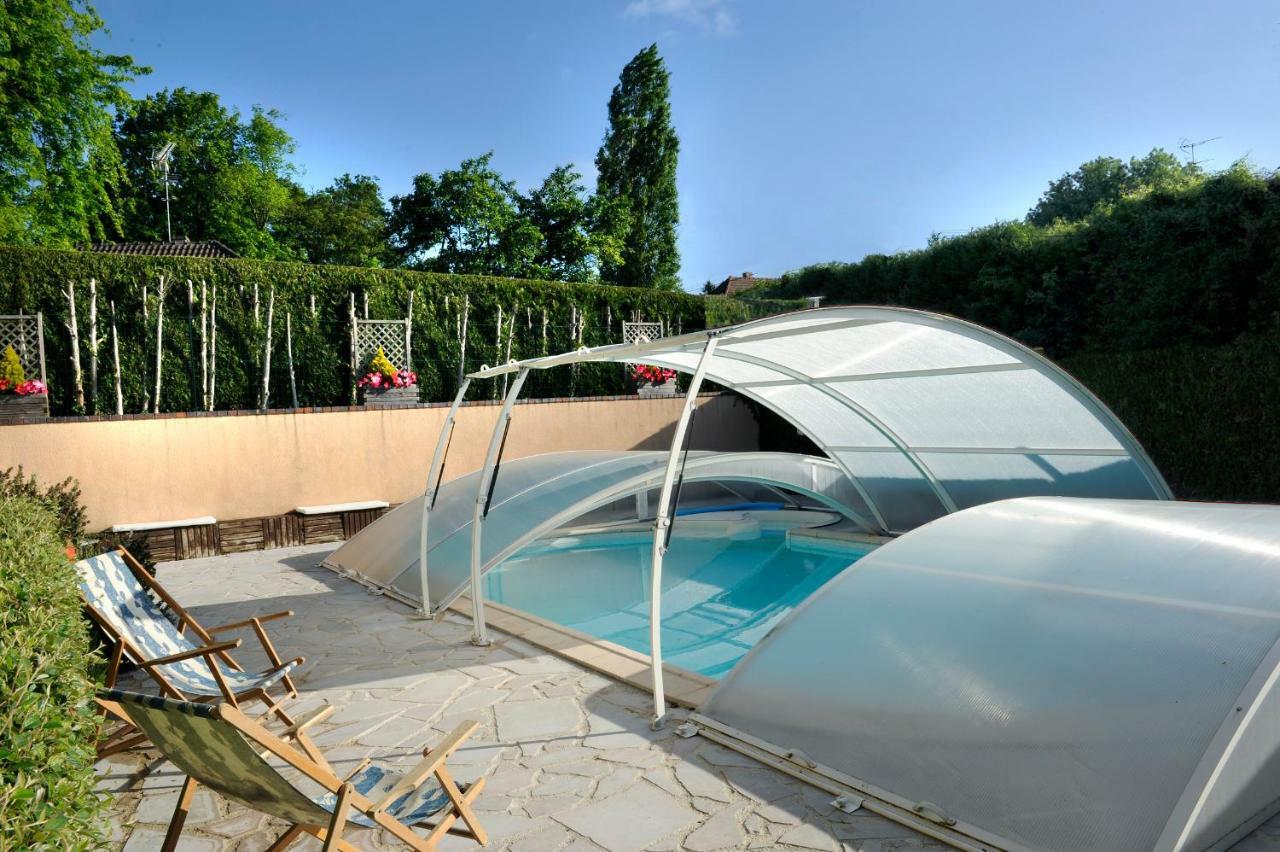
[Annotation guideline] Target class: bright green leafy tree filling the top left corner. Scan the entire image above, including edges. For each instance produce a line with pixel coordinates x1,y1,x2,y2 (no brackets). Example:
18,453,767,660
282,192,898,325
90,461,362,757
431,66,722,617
0,0,150,247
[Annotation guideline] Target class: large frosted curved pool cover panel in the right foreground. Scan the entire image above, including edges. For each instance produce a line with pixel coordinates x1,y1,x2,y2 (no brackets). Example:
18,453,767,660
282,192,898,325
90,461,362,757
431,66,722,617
701,498,1280,849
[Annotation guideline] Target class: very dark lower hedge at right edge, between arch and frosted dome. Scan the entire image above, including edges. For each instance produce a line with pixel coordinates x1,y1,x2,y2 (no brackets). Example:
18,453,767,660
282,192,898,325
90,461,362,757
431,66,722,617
1062,334,1280,503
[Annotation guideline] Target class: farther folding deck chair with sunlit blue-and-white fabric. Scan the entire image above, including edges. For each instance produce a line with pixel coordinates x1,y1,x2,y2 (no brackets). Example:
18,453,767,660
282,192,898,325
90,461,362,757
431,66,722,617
76,549,305,757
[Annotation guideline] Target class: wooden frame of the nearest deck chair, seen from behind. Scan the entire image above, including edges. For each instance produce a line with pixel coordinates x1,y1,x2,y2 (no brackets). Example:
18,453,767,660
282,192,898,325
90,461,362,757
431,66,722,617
97,697,489,852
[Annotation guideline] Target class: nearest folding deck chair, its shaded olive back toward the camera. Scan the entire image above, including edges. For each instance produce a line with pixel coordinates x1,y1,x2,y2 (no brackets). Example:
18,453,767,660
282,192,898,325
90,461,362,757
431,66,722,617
97,690,488,852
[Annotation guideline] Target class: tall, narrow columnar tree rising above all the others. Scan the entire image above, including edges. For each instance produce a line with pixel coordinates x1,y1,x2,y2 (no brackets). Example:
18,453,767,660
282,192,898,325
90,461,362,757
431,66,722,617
595,45,680,289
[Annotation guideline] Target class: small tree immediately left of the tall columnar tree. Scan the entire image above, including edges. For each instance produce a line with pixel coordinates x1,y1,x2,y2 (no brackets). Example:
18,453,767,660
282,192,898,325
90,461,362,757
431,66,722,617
520,165,599,281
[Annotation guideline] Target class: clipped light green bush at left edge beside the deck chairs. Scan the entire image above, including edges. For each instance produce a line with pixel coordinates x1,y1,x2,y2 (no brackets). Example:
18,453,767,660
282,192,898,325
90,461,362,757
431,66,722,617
0,495,104,849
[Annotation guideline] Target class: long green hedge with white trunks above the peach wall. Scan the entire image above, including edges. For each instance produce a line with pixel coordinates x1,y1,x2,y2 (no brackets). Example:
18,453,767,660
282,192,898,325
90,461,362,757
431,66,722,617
0,247,705,414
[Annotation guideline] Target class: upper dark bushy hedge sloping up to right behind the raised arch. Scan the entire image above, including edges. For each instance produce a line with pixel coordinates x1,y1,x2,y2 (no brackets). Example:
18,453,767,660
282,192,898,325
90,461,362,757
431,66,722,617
751,165,1280,358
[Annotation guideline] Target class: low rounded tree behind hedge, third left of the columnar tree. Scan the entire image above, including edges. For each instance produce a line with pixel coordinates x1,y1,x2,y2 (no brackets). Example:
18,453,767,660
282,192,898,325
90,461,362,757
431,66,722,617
279,174,390,266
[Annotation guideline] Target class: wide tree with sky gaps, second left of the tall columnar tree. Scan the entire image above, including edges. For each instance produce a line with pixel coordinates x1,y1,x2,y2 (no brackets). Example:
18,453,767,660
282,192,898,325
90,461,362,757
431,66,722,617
390,151,541,278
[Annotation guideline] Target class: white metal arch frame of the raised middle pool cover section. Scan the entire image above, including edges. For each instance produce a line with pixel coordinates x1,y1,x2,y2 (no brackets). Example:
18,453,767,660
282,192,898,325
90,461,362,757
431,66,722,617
450,307,1172,725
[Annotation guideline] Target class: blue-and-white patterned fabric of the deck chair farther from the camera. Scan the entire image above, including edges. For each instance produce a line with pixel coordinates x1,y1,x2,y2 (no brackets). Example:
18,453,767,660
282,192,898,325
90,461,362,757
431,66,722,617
76,551,297,696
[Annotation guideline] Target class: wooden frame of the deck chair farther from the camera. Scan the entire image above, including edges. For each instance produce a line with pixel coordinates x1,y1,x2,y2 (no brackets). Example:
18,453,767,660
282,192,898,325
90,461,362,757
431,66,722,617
81,548,306,760
